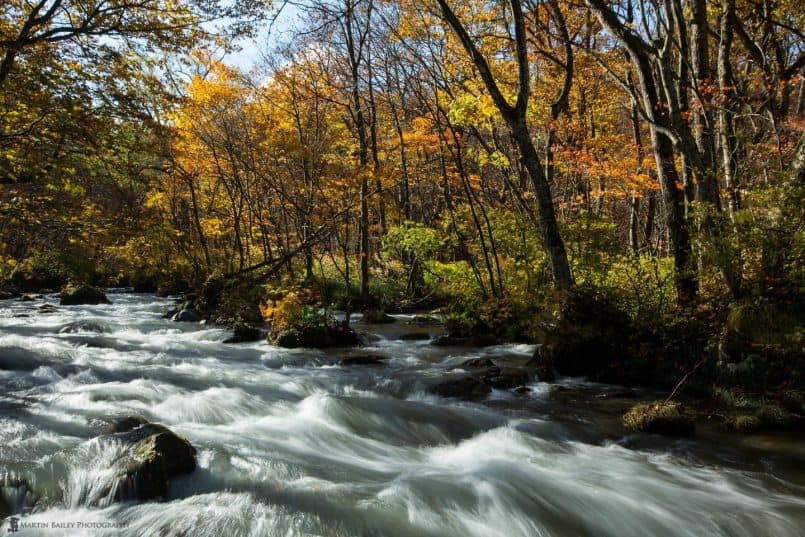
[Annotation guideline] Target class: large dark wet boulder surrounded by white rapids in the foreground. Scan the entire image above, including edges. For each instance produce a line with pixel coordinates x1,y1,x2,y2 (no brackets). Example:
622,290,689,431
91,418,196,505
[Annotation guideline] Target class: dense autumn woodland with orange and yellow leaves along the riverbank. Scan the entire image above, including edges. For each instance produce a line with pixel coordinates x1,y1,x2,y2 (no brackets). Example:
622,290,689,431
0,0,805,425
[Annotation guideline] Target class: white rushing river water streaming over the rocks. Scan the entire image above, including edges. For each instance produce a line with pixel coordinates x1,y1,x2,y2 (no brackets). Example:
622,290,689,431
0,293,805,537
